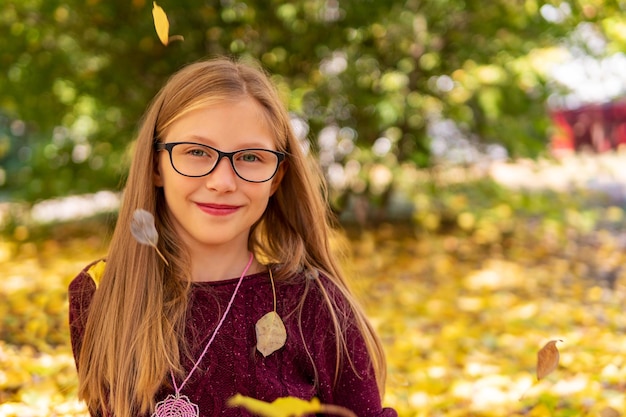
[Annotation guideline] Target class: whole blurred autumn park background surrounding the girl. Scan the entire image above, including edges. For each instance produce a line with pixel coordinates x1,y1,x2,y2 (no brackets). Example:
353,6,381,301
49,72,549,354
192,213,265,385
0,0,626,417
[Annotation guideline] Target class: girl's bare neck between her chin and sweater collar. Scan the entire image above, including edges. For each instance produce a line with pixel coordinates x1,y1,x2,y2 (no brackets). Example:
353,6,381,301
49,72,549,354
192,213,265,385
186,245,265,282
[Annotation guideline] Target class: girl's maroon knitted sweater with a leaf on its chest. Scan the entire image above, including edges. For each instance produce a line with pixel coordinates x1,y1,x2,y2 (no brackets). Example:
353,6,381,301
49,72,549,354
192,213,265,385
69,264,397,417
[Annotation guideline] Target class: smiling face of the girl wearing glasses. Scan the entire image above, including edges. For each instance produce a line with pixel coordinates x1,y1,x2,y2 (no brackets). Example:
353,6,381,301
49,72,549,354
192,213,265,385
155,98,282,251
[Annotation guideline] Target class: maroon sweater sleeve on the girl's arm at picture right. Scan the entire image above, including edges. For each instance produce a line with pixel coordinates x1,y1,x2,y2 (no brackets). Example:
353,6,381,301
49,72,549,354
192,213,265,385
304,276,397,417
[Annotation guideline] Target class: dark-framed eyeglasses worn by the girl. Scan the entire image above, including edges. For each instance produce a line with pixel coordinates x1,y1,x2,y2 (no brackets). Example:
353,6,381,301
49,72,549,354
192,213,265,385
154,142,285,182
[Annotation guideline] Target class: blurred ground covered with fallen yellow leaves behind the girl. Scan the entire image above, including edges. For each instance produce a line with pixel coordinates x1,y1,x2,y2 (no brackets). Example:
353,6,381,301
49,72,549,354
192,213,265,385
0,183,626,417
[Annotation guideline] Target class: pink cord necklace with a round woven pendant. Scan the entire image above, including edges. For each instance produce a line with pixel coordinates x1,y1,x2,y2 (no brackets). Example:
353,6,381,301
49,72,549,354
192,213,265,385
152,253,253,417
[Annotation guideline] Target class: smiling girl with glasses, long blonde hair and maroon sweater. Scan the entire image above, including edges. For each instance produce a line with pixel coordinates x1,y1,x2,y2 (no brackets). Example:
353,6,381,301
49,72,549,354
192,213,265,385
69,59,396,417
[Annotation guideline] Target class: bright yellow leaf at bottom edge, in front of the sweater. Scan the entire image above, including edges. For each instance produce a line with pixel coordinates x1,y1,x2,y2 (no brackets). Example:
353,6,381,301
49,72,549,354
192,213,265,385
228,394,322,417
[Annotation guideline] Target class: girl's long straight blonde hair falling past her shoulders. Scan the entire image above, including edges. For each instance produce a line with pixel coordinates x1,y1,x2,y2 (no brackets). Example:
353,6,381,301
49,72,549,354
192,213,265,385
78,58,385,417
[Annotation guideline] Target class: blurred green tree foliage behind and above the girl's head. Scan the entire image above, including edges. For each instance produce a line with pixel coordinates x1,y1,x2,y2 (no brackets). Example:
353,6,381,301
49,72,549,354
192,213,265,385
0,0,624,201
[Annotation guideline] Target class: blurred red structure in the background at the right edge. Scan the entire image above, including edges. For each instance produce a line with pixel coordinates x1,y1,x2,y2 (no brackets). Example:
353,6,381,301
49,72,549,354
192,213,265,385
550,101,626,154
